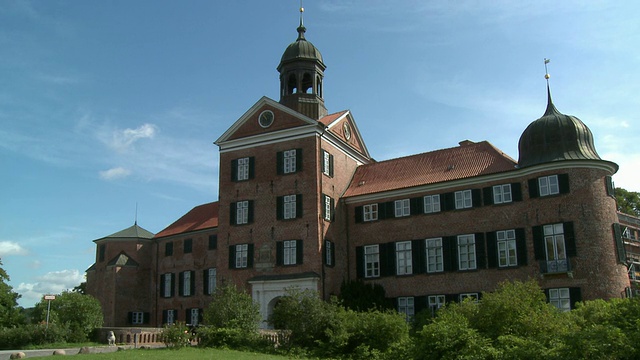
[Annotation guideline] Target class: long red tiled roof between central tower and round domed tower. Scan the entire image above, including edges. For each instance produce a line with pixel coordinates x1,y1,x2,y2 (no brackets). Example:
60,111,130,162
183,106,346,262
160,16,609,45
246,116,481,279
344,140,516,197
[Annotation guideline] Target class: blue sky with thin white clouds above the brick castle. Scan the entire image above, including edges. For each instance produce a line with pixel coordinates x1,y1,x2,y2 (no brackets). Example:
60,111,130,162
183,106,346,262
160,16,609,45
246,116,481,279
0,0,640,307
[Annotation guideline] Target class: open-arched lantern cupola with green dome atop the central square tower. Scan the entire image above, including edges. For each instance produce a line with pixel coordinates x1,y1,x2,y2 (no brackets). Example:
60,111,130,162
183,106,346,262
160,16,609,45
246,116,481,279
278,8,327,120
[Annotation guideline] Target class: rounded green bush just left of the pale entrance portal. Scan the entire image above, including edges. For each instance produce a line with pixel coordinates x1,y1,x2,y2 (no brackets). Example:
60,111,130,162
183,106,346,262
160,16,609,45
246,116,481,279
204,284,260,332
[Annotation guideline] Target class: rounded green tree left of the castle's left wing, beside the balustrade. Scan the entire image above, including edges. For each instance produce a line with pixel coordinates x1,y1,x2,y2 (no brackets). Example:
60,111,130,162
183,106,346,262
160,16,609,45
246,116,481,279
34,291,103,342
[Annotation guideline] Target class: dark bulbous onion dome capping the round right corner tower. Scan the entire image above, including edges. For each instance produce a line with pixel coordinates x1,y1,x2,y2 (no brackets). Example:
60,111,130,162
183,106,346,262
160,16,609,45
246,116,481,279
518,85,601,168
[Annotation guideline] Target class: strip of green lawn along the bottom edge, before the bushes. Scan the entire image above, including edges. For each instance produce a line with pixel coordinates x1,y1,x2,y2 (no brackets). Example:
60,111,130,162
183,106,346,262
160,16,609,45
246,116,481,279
76,348,302,360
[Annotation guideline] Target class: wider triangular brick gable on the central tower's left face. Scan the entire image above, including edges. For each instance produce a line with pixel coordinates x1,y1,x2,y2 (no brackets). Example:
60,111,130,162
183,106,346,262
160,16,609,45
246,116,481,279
215,96,317,145
